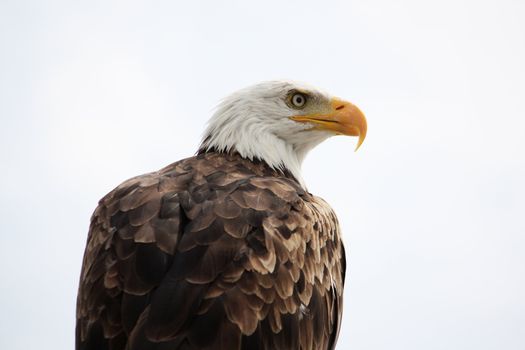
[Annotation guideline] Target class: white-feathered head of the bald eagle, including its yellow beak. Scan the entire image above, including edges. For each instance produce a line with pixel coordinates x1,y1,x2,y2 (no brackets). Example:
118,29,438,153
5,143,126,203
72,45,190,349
199,81,367,187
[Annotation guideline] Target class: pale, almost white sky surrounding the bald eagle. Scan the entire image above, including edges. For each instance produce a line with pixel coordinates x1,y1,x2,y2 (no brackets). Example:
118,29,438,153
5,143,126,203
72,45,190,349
0,0,525,350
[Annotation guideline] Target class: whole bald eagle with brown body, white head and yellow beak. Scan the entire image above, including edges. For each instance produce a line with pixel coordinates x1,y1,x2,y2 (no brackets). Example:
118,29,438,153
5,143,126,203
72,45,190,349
76,81,367,350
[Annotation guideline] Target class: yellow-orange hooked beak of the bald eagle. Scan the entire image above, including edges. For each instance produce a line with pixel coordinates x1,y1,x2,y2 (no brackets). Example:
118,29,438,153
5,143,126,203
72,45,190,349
290,98,366,151
